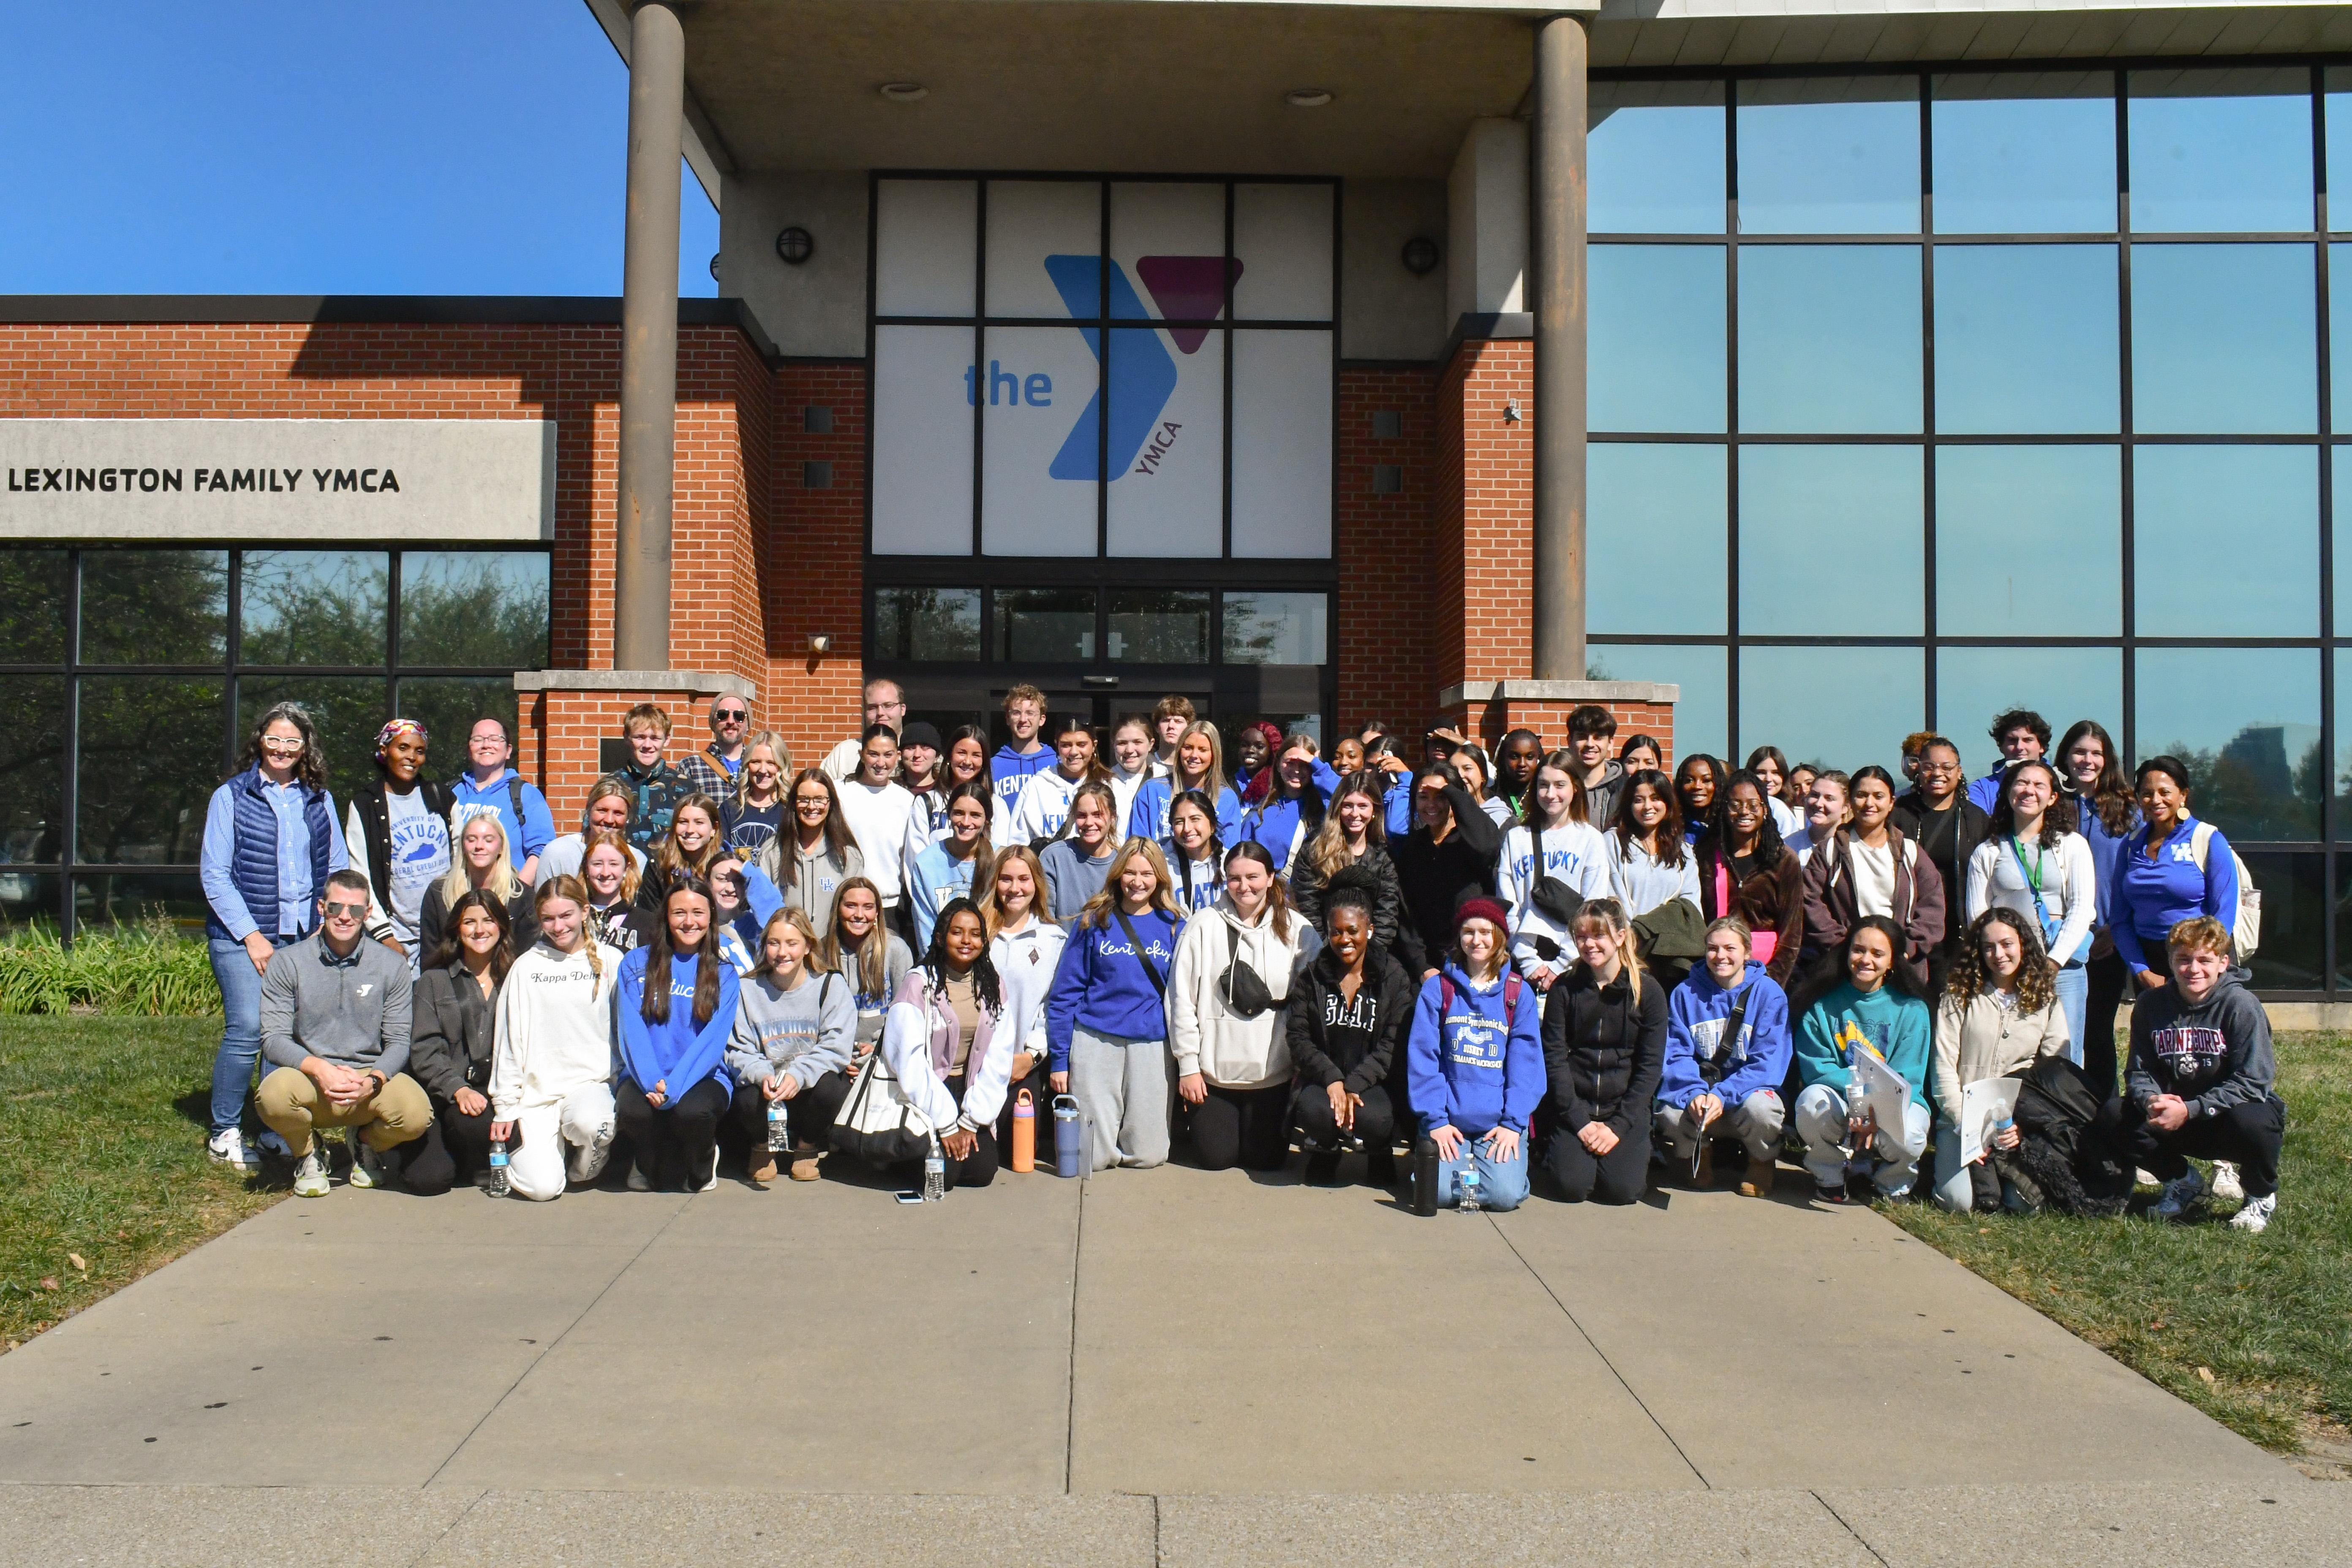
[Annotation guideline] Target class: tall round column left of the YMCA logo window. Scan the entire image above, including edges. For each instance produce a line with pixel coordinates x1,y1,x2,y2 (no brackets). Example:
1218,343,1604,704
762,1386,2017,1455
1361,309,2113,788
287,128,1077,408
612,5,686,670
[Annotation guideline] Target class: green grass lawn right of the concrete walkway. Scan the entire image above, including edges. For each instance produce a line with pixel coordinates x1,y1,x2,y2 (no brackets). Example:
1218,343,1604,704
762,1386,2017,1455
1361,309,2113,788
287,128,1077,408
1881,1034,2352,1457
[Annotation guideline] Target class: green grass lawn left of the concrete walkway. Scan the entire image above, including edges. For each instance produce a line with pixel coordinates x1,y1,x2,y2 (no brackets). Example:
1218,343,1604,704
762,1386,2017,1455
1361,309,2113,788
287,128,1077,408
0,1015,285,1349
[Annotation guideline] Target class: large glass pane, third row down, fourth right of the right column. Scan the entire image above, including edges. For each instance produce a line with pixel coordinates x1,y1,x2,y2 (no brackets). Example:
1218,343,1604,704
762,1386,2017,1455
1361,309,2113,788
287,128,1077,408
2131,446,2319,637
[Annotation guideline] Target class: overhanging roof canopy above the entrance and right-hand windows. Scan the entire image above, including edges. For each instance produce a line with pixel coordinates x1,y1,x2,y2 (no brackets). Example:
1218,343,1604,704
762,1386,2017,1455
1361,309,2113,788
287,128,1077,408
621,0,2352,179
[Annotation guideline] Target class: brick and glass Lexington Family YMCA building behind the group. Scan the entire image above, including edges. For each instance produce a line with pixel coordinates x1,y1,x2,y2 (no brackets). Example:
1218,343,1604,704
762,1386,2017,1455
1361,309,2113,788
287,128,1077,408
0,0,2352,999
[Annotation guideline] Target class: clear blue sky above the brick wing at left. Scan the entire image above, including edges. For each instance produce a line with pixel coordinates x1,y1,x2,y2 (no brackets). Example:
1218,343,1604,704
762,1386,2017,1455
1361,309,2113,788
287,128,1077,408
0,0,717,296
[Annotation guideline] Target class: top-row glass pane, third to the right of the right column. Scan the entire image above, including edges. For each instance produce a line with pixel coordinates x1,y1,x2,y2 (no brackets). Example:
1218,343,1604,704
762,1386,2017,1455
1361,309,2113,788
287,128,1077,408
1931,71,2115,235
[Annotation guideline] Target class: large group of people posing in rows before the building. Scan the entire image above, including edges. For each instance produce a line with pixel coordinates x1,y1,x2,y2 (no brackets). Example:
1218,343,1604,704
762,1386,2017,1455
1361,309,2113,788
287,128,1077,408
202,679,2286,1232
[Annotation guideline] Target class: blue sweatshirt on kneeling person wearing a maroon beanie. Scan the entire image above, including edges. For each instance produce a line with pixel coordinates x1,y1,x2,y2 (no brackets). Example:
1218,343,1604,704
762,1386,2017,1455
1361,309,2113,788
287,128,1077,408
1407,964,1545,1138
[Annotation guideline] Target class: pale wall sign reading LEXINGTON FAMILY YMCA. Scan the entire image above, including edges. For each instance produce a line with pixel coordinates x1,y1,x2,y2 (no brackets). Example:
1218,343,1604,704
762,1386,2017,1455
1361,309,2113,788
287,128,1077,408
0,419,555,541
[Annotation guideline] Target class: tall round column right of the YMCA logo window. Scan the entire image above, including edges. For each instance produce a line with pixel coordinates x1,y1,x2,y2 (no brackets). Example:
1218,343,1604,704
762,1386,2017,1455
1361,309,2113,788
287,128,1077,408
1529,16,1590,679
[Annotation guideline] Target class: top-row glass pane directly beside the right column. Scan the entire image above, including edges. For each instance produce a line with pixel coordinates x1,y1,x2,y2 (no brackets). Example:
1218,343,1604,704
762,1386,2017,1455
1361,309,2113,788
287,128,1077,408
1585,82,1726,235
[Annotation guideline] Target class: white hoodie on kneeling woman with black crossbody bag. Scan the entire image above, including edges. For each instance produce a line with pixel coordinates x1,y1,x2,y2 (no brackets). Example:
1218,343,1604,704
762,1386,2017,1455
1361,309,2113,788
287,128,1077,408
1169,896,1322,1089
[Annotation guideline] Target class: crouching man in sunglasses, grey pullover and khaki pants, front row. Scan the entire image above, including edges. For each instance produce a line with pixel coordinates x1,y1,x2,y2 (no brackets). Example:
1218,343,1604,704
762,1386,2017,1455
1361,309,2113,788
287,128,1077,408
256,870,438,1199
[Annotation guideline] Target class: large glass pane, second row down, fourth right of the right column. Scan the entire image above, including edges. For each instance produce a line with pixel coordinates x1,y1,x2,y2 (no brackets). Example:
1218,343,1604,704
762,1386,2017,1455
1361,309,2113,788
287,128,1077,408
2131,245,2319,435
